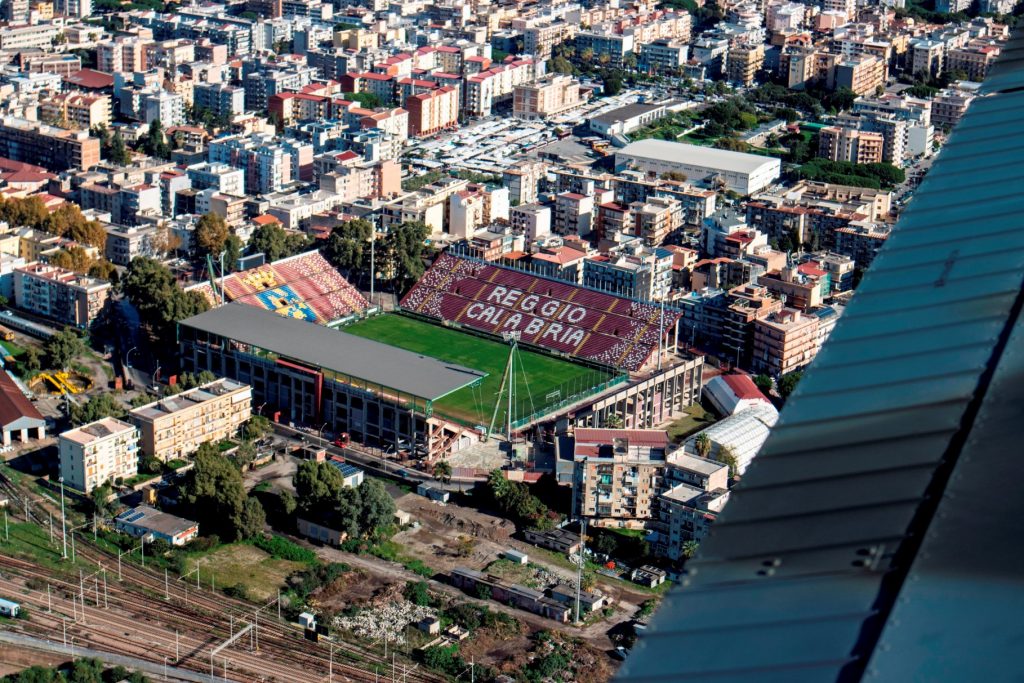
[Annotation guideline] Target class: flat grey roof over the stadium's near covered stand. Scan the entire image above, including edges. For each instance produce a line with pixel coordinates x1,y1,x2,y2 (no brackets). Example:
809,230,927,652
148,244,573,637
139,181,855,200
181,303,484,400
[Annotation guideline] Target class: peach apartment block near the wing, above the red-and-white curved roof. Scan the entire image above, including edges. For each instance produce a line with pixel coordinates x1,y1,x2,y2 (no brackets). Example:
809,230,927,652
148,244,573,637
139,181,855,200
753,308,818,377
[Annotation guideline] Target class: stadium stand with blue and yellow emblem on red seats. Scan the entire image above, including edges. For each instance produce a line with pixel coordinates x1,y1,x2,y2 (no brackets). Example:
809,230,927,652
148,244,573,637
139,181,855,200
189,251,370,325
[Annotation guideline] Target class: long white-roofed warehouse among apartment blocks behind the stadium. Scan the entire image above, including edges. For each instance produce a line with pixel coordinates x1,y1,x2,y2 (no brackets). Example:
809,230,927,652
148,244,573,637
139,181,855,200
615,139,782,195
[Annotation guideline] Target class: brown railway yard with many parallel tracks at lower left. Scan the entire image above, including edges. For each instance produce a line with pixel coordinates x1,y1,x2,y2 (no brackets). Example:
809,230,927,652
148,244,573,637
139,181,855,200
0,471,444,682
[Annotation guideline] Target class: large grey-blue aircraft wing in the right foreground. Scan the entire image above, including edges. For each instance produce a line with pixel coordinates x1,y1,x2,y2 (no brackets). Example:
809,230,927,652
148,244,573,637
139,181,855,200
618,28,1024,683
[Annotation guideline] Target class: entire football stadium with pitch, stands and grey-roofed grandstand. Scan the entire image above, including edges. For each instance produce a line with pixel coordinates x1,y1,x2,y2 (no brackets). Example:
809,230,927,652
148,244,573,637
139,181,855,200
178,252,701,460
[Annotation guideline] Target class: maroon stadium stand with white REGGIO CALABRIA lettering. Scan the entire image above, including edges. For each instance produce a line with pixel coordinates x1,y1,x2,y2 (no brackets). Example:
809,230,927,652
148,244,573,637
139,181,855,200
401,254,679,372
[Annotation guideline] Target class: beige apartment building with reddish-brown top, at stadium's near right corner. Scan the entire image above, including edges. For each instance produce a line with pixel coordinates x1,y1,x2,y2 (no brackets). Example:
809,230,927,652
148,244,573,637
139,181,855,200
572,428,669,528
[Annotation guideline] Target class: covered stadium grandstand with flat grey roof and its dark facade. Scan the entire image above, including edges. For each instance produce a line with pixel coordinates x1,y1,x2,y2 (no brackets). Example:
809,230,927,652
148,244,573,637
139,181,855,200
178,303,483,460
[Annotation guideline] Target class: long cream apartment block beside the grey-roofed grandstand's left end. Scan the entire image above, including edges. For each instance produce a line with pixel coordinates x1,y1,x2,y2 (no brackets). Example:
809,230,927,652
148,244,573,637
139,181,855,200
128,379,252,463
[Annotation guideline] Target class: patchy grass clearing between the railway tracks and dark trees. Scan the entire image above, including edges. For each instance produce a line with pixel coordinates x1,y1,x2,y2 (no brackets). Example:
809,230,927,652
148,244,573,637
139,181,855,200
187,543,306,600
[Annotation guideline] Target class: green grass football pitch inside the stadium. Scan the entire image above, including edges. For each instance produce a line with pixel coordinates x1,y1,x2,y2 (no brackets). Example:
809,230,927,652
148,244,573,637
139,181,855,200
342,314,614,431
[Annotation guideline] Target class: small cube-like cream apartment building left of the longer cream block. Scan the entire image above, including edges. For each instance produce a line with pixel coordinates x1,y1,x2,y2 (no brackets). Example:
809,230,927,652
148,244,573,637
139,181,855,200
57,418,139,494
